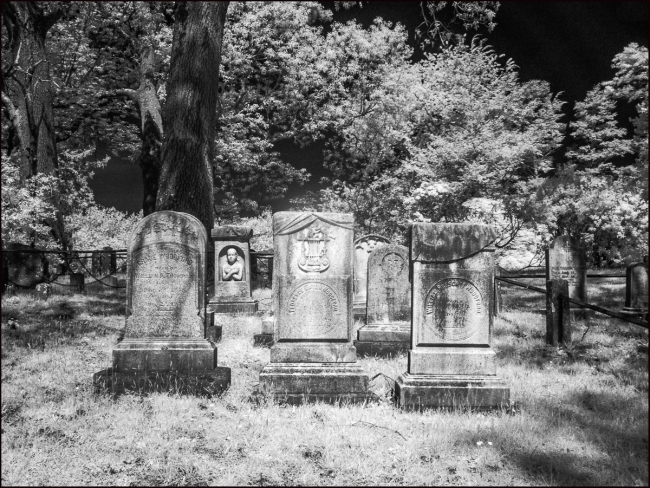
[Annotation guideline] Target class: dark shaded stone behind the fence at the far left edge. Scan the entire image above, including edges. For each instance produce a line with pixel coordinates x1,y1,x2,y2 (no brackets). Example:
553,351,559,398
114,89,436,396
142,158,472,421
2,242,50,288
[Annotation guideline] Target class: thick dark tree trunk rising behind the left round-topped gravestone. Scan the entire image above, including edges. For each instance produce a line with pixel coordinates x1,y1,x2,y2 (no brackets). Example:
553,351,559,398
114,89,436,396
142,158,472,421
156,2,228,230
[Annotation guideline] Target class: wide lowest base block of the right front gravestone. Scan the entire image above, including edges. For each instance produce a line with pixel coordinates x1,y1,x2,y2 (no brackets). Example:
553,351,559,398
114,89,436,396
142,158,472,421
395,373,510,410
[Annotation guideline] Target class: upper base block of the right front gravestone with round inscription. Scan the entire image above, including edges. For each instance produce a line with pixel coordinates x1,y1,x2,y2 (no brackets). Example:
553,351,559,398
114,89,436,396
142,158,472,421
408,347,497,376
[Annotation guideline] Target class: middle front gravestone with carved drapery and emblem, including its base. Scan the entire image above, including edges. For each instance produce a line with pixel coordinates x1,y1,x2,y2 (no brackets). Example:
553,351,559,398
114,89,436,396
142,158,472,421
260,212,368,403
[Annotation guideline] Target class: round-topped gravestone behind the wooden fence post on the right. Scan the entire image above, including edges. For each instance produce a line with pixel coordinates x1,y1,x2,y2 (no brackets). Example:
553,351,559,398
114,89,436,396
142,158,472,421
546,236,587,317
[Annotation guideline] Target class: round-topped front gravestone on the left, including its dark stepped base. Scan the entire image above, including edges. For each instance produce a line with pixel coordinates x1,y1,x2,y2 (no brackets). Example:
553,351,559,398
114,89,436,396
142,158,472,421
94,211,230,394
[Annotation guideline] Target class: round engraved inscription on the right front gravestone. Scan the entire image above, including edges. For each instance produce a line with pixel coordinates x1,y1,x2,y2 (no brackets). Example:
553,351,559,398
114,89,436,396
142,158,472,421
424,278,478,341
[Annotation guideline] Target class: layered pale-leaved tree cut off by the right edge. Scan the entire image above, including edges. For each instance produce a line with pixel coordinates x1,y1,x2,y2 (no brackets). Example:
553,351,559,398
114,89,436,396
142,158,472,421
538,43,648,266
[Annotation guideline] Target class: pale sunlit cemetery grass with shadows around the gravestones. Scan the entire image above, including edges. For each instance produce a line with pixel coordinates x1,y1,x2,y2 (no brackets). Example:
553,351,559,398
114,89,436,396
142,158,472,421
2,279,649,486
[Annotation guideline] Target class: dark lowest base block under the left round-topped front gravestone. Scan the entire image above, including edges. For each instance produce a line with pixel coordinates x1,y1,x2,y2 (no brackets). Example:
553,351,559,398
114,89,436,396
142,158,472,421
93,367,230,397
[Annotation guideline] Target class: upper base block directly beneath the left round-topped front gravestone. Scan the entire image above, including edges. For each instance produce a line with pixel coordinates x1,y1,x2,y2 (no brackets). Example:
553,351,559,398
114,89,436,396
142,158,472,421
113,337,217,371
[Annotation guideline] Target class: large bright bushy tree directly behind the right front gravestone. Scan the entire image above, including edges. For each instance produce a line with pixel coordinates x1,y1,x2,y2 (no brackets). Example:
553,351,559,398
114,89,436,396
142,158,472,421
312,40,563,244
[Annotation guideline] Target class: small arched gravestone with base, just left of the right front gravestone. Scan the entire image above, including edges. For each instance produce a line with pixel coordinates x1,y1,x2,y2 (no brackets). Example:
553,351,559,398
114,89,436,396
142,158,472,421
354,244,411,354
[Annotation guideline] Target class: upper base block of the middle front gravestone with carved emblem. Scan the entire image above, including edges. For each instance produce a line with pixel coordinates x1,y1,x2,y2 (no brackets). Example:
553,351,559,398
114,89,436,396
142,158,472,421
271,342,357,363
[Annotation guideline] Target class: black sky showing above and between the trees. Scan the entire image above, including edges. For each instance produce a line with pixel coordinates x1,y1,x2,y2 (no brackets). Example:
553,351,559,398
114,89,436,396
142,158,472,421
90,2,648,212
